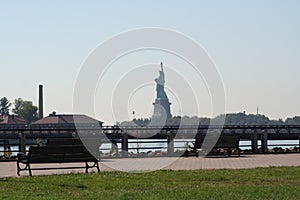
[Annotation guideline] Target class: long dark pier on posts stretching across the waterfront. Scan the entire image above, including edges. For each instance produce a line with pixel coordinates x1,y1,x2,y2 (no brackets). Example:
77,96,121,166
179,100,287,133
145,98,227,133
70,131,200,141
0,123,300,157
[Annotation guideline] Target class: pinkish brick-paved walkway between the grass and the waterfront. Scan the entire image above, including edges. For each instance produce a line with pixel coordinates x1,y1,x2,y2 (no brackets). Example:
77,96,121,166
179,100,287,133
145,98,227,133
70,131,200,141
0,154,300,177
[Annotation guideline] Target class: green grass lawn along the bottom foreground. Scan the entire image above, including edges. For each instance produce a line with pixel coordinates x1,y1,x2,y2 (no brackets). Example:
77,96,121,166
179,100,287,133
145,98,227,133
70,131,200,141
0,167,300,200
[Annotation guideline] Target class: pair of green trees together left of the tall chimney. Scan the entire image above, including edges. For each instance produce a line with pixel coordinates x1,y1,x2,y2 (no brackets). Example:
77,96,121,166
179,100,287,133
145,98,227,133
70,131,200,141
0,97,38,123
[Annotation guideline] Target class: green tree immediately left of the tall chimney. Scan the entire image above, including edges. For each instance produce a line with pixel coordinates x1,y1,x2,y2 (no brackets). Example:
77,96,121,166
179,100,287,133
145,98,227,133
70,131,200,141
13,98,38,123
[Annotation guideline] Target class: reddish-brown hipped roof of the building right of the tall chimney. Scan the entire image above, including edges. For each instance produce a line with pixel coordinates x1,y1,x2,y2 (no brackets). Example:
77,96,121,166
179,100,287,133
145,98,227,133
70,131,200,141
31,112,103,125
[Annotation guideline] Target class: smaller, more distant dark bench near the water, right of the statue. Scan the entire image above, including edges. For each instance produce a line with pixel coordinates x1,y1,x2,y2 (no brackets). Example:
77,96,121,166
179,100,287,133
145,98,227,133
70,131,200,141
190,135,240,157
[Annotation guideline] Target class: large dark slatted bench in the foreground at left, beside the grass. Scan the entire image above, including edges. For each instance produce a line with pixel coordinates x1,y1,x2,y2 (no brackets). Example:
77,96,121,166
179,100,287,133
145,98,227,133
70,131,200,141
17,139,100,176
